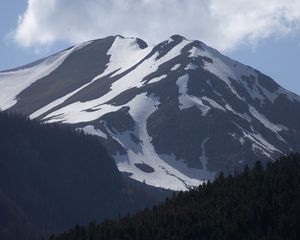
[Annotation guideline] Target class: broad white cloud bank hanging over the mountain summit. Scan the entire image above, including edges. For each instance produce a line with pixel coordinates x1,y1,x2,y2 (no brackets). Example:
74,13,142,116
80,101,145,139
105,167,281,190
14,0,300,51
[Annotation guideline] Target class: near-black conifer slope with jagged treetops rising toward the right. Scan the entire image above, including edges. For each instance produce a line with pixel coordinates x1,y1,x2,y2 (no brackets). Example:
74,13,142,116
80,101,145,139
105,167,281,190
50,154,300,240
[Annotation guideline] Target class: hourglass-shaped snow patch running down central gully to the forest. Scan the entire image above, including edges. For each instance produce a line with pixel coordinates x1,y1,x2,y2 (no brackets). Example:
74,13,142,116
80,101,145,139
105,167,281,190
114,93,203,190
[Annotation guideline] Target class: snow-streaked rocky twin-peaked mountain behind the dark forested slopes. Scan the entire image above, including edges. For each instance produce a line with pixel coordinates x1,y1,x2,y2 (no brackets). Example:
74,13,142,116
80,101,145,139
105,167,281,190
0,35,300,190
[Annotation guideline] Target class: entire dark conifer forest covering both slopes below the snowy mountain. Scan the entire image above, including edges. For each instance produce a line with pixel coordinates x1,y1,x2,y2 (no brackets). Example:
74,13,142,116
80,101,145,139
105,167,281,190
0,112,300,240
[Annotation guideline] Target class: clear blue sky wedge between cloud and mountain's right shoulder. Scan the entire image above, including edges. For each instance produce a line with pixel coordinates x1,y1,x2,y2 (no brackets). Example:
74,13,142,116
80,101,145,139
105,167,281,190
227,33,300,95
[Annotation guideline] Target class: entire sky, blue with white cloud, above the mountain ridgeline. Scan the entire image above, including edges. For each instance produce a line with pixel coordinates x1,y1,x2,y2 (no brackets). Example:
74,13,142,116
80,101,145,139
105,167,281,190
0,0,300,95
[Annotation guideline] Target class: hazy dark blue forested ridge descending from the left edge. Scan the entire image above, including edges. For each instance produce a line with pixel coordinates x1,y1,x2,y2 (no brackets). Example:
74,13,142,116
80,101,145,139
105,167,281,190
0,113,169,240
